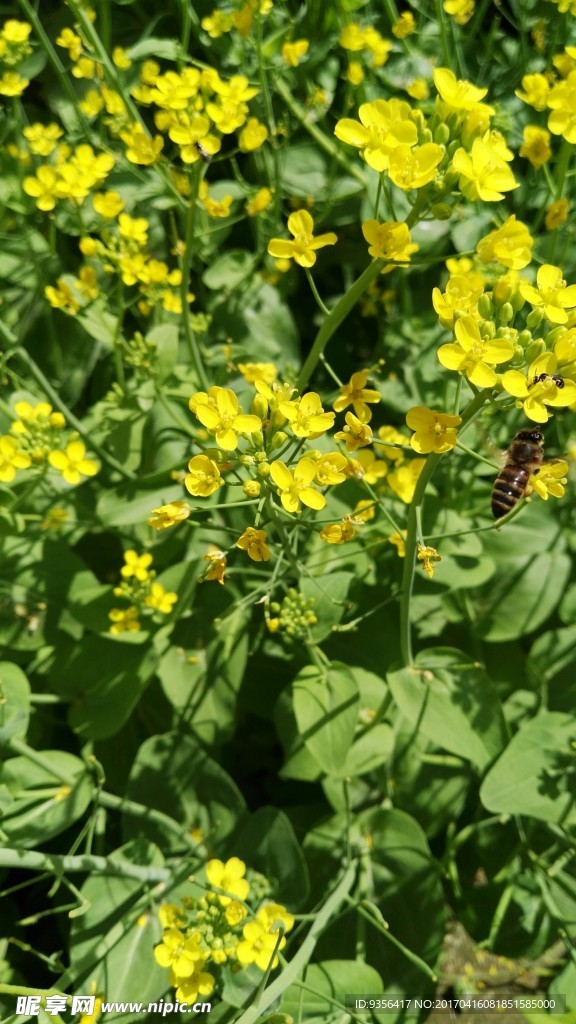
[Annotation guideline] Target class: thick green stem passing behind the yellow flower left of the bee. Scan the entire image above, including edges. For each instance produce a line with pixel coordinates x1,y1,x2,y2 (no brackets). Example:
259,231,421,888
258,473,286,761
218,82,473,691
400,388,492,666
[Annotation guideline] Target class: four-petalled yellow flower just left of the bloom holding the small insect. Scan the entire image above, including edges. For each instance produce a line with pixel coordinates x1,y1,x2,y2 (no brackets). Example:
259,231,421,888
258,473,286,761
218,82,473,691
438,316,513,387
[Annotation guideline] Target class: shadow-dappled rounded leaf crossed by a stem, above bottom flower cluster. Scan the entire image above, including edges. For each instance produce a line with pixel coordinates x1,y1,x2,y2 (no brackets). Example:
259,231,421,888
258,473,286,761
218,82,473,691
124,732,245,850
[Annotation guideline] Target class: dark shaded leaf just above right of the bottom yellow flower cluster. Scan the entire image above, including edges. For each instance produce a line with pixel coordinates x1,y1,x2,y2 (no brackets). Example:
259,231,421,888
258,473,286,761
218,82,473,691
228,807,310,908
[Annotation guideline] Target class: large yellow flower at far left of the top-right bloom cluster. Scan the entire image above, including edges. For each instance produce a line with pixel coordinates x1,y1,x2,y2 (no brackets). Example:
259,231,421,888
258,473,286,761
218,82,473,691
334,99,418,171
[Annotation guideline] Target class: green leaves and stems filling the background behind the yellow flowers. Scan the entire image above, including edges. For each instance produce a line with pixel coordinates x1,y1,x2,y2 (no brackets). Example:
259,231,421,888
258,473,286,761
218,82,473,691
0,0,576,1024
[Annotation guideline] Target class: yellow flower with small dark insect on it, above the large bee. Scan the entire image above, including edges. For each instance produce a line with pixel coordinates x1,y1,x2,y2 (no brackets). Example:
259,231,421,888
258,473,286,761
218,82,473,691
502,352,576,423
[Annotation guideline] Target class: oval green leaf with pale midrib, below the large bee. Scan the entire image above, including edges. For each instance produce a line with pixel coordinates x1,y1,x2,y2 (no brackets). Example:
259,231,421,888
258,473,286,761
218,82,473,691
475,551,572,641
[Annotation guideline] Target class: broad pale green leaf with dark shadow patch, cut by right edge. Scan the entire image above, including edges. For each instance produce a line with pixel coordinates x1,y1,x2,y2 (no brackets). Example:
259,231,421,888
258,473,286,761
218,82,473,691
480,712,576,824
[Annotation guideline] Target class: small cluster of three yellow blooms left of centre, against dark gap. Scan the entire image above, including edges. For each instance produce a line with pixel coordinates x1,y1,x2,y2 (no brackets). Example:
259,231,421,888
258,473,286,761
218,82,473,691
109,552,178,636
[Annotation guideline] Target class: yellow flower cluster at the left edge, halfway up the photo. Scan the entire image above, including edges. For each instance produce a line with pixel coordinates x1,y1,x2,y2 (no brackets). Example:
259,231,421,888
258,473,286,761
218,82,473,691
0,400,98,484
